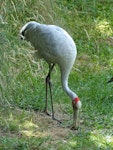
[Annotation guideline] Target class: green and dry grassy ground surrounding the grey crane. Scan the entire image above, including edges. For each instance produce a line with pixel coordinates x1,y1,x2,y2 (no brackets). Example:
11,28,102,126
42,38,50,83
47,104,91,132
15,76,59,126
0,0,113,150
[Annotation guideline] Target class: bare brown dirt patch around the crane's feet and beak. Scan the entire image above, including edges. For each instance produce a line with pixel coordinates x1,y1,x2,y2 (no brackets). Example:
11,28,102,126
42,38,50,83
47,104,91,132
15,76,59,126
30,104,78,140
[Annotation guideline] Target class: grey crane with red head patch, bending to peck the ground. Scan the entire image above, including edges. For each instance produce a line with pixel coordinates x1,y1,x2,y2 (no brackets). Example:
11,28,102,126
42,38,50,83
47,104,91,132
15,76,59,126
20,21,81,129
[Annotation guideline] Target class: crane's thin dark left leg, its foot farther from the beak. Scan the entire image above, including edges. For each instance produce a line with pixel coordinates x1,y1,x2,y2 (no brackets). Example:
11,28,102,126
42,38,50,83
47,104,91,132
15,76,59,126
44,64,55,115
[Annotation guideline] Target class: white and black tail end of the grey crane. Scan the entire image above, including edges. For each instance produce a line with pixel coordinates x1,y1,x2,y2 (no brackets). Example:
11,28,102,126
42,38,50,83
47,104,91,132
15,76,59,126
20,21,38,40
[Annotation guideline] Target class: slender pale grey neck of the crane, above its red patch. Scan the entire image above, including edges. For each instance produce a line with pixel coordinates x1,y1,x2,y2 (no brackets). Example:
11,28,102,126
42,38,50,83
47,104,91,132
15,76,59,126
61,69,77,100
